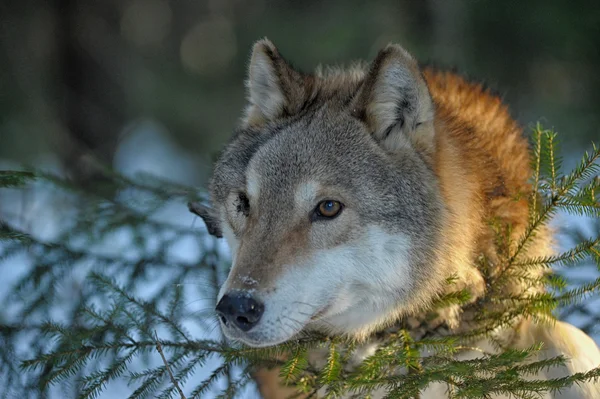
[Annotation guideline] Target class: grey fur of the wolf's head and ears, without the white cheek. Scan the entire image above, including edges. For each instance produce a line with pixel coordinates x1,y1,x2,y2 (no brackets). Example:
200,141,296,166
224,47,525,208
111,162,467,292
204,41,445,348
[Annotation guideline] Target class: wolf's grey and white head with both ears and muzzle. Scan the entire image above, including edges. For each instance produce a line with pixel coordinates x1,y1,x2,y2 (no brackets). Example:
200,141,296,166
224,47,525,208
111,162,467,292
203,40,445,346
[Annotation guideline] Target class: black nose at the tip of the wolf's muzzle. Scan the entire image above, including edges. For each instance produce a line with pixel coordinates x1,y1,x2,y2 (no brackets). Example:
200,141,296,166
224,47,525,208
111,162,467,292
216,292,265,331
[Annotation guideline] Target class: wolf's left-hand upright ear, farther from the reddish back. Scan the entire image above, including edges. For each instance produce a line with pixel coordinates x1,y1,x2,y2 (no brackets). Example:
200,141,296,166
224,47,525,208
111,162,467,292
244,39,310,126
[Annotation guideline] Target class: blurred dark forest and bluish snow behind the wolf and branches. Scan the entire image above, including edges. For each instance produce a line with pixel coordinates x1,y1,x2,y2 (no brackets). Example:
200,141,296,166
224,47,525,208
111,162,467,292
0,0,600,397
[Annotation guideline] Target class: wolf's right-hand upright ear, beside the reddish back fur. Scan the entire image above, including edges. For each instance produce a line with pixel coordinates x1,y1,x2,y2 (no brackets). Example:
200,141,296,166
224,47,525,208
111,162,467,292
352,44,434,151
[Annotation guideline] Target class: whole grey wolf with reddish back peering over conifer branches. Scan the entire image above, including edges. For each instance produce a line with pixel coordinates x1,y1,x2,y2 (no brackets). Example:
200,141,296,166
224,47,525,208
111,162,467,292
194,39,600,398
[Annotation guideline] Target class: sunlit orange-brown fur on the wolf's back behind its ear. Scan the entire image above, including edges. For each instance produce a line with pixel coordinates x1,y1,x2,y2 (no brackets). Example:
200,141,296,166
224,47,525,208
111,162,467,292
424,68,531,268
